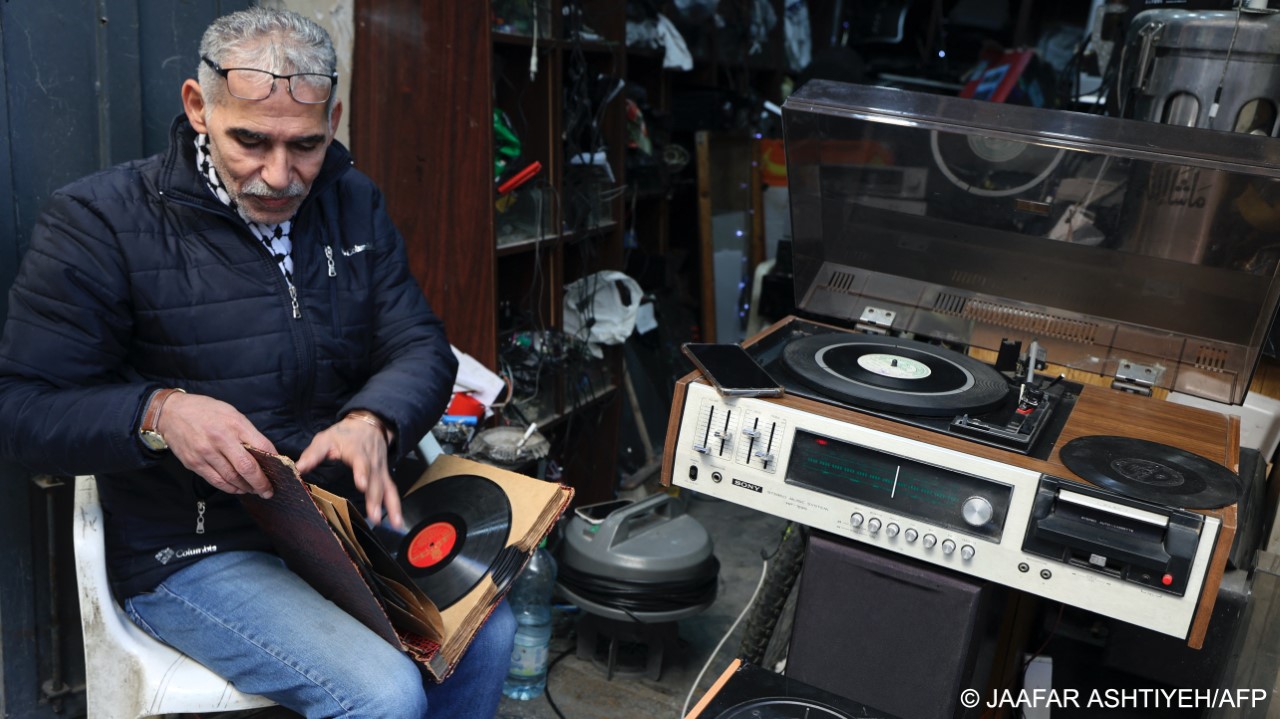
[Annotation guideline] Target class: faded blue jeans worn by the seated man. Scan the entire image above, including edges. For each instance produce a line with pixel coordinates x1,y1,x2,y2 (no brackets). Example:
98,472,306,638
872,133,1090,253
124,551,516,719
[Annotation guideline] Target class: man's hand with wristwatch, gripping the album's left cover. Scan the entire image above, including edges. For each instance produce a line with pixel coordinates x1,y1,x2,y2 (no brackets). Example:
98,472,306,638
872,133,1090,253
156,393,275,499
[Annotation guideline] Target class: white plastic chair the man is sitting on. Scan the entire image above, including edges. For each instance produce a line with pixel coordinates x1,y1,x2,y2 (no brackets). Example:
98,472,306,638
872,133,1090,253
72,476,275,719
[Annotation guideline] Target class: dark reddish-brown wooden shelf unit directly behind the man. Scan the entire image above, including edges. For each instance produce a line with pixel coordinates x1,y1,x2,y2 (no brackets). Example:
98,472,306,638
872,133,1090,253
351,0,637,503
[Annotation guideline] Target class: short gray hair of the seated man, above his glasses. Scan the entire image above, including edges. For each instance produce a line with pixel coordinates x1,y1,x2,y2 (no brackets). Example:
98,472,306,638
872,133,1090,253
196,8,338,113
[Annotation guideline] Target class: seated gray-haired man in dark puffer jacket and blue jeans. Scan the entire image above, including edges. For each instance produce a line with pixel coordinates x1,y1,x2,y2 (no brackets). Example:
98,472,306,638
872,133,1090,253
0,9,515,719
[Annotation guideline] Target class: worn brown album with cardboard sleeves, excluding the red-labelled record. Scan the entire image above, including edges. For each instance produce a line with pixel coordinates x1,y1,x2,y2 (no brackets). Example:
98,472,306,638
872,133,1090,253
241,449,573,682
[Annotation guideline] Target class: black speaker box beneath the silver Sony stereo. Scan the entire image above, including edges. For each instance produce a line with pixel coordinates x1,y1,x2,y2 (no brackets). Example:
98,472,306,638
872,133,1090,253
786,531,1007,719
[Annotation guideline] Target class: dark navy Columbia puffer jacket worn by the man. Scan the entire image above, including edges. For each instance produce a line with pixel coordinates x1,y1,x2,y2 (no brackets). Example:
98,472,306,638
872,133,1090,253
0,116,457,597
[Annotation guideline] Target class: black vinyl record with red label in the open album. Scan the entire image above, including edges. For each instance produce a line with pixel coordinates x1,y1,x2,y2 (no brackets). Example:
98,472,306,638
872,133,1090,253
387,475,511,610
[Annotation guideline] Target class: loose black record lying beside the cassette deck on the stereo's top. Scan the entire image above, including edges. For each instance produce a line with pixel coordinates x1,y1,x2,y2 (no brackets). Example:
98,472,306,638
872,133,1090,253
1059,435,1242,509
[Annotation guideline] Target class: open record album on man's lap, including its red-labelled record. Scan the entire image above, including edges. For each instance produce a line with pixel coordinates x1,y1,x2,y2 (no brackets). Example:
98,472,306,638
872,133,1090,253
241,448,573,682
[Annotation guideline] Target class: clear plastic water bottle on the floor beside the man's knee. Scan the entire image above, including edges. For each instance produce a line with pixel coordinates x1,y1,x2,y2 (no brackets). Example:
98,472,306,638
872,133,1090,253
502,541,556,699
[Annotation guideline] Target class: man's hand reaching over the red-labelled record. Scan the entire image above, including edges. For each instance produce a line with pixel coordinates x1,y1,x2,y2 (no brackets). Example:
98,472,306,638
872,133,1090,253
297,415,404,528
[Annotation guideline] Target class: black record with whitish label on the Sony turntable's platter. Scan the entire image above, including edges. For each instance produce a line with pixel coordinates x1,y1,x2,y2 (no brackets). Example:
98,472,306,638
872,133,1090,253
782,333,1010,417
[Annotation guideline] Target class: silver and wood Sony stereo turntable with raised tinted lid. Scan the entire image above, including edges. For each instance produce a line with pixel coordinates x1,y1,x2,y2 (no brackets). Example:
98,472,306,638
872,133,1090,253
663,81,1280,647
